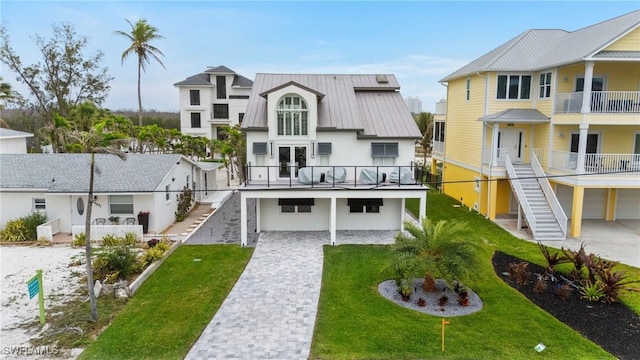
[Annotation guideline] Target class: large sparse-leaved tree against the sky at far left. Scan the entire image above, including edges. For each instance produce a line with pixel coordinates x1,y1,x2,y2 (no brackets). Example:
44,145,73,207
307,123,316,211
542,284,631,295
0,23,113,124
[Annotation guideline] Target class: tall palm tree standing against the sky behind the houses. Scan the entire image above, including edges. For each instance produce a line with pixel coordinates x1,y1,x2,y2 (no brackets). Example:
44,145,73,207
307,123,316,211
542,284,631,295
115,19,165,126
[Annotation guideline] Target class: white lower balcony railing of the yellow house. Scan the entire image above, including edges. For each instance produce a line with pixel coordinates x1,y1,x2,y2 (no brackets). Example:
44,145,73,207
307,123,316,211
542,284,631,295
551,151,640,174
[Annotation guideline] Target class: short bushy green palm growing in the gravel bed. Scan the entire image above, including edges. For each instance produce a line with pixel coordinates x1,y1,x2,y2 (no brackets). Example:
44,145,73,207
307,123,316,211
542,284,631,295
393,218,476,291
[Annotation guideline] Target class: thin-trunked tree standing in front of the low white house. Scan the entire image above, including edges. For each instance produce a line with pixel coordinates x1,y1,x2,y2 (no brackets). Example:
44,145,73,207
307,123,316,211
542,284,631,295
70,121,126,321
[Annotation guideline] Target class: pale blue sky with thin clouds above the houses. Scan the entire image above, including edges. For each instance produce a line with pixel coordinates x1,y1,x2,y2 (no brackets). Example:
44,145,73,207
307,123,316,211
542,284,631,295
0,0,640,111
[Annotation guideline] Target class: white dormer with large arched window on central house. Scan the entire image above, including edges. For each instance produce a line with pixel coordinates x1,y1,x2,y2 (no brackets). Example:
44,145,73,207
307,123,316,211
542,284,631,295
260,81,324,140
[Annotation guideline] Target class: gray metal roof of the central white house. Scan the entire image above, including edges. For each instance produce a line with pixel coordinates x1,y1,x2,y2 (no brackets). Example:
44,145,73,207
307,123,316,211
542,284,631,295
242,74,421,138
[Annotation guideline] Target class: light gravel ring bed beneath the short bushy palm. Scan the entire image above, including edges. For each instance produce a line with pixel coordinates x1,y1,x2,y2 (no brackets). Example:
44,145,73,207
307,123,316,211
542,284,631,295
378,279,482,317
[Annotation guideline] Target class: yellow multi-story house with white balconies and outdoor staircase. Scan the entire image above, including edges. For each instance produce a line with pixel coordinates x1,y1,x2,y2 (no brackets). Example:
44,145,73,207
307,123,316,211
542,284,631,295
433,11,640,239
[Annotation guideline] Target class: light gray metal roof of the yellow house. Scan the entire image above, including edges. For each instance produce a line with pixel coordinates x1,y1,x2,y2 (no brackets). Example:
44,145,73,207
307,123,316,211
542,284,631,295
441,10,640,81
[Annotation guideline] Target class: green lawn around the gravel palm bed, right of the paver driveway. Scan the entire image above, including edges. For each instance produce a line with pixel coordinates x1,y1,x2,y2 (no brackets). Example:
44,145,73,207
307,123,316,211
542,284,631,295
311,192,640,359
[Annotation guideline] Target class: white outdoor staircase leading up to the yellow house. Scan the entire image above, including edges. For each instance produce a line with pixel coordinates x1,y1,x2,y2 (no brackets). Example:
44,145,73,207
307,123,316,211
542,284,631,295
507,155,567,240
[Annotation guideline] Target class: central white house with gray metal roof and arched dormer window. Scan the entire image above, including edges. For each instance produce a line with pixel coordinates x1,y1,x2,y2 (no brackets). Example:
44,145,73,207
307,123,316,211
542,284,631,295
240,74,426,245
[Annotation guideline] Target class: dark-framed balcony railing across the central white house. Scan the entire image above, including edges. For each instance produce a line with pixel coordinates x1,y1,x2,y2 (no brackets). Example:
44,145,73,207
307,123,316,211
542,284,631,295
245,163,422,188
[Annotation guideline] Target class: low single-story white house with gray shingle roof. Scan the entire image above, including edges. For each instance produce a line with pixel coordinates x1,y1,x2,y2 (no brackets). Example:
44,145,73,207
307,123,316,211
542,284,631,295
0,154,215,233
